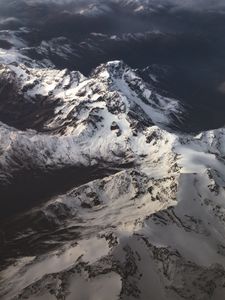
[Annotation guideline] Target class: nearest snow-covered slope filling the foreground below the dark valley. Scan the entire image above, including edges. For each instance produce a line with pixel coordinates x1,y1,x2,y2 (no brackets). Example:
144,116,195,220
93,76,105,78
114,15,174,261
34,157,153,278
1,126,225,300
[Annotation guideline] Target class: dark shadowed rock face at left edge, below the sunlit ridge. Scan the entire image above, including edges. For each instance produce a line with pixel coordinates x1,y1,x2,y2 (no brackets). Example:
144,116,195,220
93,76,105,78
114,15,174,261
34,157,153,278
0,65,58,130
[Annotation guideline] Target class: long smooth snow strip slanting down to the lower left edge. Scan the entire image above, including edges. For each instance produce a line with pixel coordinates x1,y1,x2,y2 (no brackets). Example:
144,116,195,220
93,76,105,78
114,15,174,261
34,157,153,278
1,237,109,297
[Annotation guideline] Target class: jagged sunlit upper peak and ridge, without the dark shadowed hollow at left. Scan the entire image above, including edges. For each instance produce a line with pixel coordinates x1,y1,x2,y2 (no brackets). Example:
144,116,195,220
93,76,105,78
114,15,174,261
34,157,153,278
0,57,184,130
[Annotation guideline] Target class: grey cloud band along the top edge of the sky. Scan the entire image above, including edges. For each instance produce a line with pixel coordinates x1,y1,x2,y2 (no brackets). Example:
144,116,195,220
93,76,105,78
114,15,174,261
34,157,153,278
0,0,225,32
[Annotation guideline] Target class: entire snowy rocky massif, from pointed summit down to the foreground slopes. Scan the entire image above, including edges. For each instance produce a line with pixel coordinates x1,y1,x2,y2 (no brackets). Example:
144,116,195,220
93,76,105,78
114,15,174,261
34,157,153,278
0,37,225,300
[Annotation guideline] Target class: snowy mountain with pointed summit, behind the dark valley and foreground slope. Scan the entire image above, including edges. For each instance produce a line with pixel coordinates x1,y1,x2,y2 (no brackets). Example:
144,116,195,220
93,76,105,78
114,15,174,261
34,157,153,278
0,52,185,214
